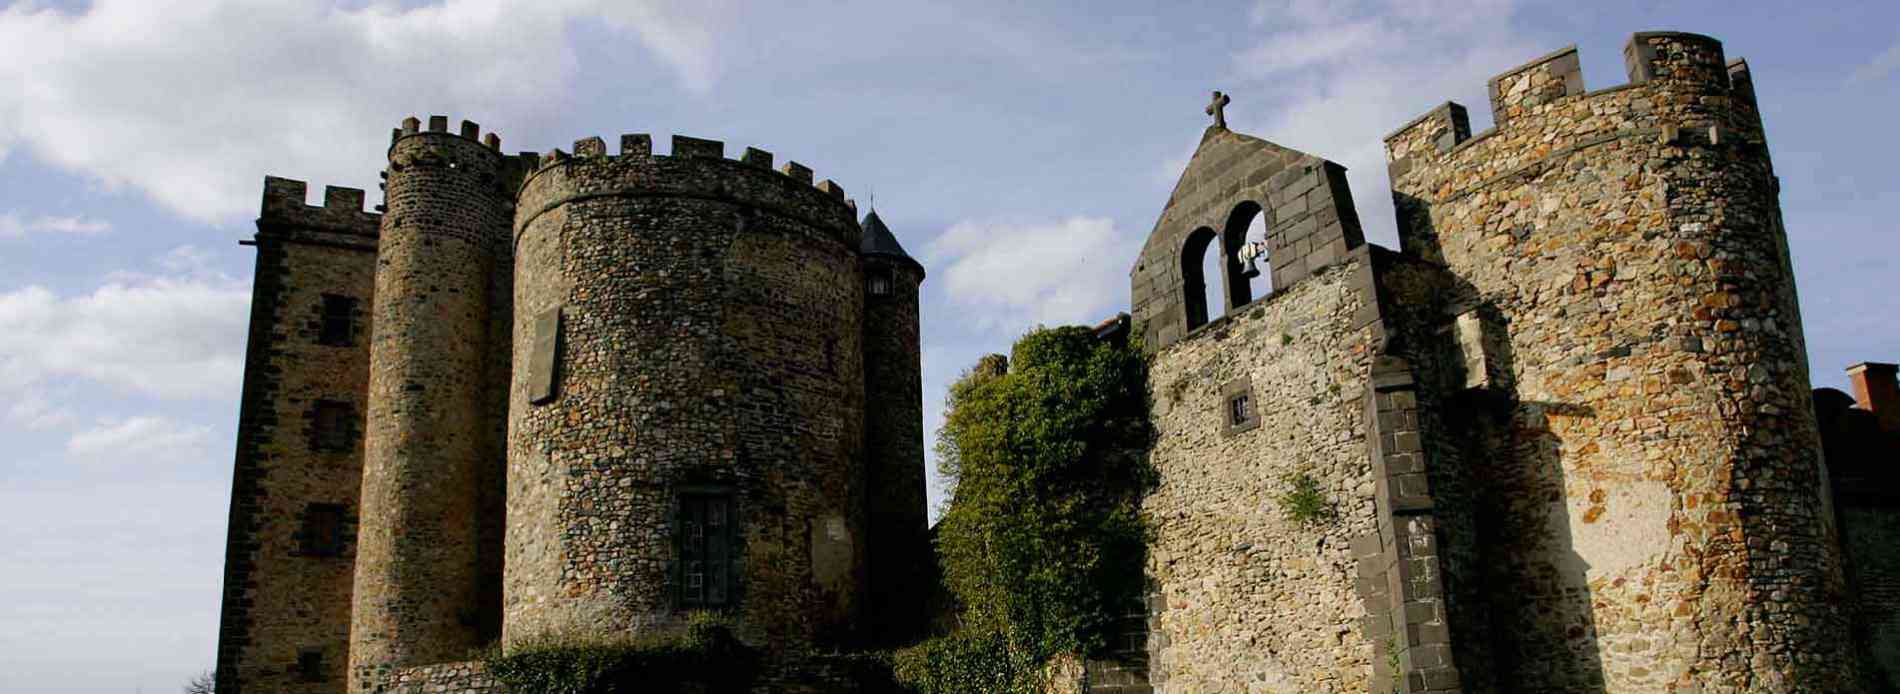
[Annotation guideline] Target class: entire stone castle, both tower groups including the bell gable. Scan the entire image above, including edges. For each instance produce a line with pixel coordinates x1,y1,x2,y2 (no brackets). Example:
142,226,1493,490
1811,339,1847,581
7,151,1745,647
219,32,1900,694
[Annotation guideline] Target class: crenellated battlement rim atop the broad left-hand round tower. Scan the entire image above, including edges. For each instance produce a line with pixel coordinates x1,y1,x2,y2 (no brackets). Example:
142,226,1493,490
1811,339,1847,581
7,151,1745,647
523,133,857,230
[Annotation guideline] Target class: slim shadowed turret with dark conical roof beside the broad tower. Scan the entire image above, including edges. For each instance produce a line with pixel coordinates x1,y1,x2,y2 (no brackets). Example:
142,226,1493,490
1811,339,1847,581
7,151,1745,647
859,209,933,645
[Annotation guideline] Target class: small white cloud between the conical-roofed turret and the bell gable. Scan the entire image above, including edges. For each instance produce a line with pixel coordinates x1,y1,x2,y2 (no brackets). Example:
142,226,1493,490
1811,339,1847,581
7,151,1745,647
923,217,1140,329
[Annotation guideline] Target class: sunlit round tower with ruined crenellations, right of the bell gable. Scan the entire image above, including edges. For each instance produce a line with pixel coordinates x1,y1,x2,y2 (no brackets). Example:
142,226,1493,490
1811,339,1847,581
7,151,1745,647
1387,32,1854,692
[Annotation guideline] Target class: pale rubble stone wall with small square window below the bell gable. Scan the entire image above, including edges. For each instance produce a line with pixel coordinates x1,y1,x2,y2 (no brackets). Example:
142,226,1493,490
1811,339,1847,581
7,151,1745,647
1144,259,1378,692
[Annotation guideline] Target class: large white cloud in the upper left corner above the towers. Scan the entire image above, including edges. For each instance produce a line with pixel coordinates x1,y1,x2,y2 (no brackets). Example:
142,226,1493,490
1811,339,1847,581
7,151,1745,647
0,0,716,222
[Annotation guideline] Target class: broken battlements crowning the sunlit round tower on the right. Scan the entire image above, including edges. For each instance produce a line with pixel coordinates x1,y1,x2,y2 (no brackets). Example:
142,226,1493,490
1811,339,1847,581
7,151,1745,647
1385,32,1754,179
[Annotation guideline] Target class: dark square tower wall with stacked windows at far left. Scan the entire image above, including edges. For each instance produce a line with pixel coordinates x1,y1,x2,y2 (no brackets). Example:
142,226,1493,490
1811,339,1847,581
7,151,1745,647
217,179,378,694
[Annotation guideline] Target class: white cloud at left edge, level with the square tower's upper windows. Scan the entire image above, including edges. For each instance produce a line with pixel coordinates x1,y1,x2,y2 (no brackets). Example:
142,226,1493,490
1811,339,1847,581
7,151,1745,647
0,274,251,399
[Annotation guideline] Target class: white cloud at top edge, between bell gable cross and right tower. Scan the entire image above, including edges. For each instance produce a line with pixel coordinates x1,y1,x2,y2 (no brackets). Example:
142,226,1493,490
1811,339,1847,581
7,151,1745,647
1227,0,1542,243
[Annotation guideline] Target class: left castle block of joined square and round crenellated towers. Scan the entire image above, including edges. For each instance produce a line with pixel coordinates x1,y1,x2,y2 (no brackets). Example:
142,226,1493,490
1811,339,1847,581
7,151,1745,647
217,116,929,694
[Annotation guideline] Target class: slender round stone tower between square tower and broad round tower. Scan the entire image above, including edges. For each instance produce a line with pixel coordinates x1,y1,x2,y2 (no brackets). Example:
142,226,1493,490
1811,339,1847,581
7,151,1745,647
350,116,513,692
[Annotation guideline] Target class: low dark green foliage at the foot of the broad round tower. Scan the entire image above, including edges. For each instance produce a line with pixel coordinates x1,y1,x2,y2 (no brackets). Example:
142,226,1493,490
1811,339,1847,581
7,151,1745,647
483,612,758,694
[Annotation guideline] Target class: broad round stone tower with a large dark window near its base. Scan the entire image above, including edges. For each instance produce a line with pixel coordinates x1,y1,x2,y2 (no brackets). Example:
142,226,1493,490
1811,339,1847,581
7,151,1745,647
504,135,866,650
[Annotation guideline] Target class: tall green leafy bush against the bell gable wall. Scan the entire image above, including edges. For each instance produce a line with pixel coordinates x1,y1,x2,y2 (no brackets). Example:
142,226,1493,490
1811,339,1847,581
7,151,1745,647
927,327,1155,665
